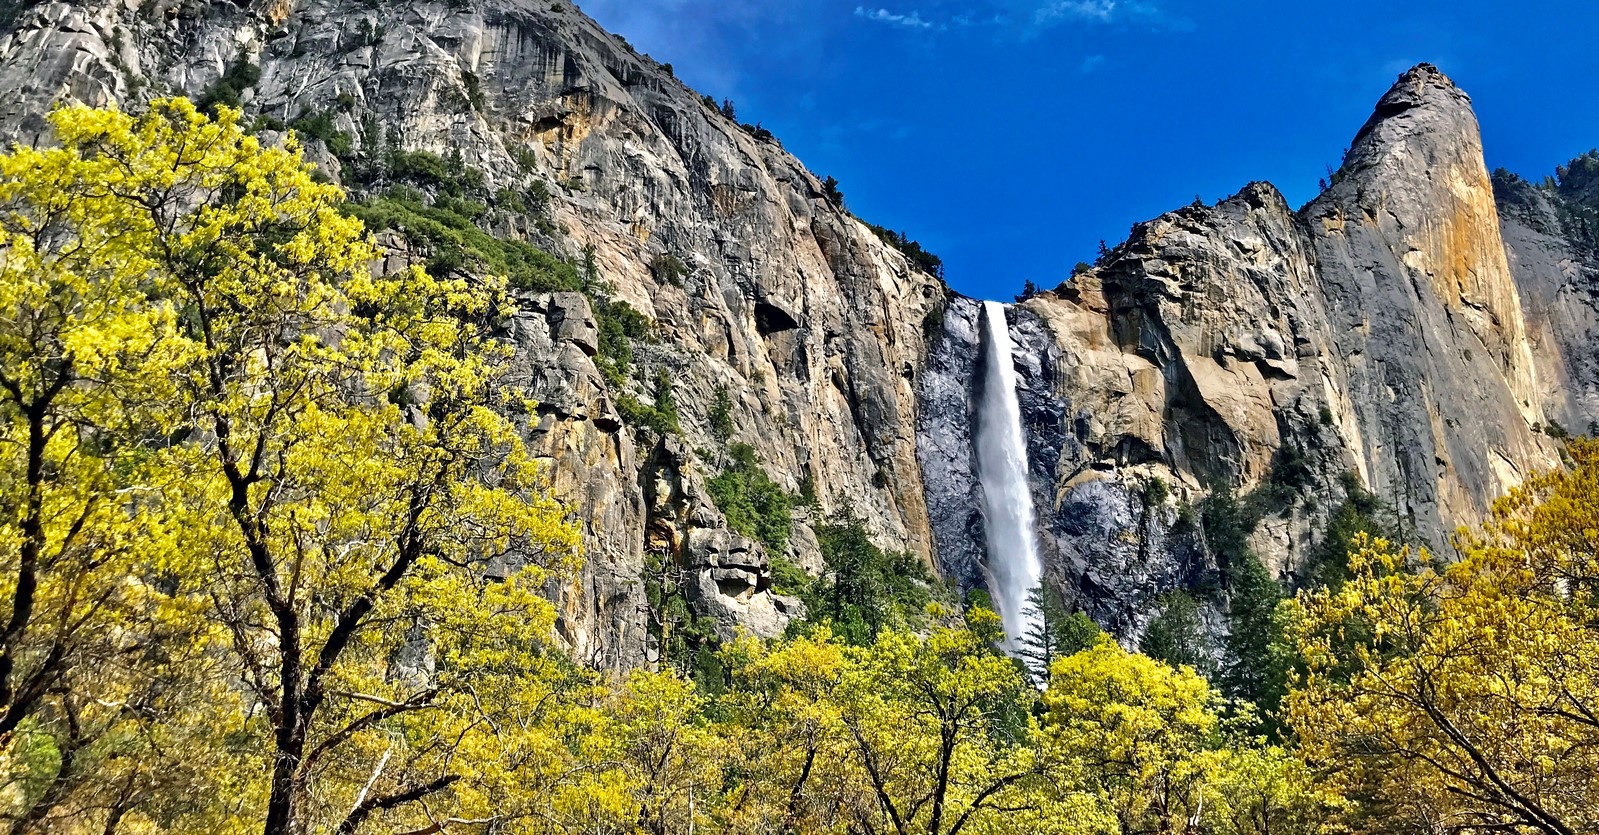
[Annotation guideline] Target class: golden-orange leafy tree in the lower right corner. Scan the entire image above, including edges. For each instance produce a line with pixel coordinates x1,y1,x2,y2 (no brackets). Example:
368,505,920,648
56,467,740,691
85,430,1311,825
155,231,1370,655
1289,440,1599,835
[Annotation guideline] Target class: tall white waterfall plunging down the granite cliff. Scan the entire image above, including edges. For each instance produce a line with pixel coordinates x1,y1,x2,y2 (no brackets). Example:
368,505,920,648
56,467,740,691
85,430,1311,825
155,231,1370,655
977,301,1043,654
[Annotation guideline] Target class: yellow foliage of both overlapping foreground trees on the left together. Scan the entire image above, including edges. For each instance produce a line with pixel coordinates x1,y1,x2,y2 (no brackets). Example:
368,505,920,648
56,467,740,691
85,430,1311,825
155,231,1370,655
0,99,577,833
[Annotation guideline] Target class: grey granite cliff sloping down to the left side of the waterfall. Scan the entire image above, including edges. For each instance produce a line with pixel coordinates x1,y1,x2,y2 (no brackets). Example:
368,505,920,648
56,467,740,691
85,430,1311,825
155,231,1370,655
0,0,945,667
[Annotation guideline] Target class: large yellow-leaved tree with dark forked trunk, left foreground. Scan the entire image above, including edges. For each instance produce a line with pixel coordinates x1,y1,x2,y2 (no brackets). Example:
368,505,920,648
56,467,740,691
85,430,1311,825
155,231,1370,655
5,99,577,833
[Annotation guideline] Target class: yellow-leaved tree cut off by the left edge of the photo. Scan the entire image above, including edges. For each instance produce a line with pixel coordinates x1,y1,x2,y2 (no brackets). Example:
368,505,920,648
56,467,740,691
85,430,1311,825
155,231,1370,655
0,99,181,739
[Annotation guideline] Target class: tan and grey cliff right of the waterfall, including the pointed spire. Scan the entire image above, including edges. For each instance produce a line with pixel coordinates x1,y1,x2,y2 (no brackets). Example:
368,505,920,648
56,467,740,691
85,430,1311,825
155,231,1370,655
921,64,1599,635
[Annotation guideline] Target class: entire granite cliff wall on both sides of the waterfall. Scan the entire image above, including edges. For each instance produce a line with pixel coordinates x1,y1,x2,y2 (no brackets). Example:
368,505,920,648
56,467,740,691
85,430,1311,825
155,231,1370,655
0,0,1599,652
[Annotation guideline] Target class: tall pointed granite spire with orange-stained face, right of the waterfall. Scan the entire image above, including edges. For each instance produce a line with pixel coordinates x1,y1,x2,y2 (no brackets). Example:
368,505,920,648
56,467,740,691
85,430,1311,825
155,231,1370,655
1305,64,1548,544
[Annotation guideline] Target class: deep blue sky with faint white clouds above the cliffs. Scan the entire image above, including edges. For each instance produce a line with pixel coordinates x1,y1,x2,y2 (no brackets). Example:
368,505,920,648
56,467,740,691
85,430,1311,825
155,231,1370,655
579,0,1599,298
